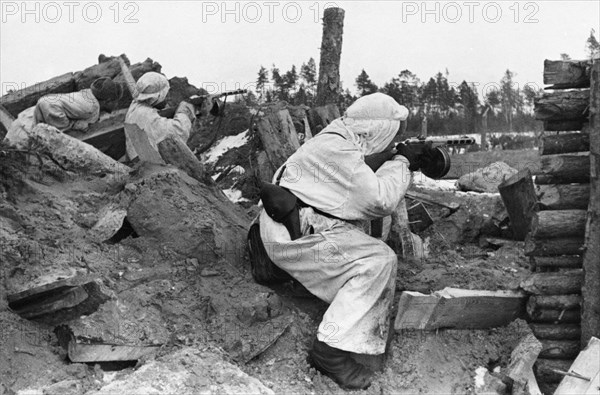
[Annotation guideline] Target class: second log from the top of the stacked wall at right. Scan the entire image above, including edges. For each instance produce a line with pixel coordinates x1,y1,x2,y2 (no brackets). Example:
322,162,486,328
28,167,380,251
534,89,590,121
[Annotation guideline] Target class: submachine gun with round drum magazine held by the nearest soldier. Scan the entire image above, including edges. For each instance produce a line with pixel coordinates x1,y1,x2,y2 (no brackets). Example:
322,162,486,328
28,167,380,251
396,137,475,180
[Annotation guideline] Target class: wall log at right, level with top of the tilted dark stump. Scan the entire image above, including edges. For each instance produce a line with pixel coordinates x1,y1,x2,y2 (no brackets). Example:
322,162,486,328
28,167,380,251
535,155,590,185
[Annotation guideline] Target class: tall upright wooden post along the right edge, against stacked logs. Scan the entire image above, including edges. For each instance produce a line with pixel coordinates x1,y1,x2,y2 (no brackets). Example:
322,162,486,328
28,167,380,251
581,60,600,344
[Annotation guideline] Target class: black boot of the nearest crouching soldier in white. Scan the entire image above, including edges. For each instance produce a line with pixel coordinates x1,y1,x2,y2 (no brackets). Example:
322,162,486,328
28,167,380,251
309,339,373,389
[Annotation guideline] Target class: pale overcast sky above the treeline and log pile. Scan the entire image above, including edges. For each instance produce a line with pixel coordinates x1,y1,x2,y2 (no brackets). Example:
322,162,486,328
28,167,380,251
0,0,600,99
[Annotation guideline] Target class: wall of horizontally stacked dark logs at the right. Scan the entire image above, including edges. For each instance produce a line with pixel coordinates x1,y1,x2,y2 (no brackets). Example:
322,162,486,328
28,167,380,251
521,61,599,387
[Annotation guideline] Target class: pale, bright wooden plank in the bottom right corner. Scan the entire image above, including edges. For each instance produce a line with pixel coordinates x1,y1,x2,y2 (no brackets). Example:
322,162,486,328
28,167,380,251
554,337,600,395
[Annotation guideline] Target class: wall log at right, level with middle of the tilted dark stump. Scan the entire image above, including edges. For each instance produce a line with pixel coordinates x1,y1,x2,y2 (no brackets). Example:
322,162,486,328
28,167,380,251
536,184,590,210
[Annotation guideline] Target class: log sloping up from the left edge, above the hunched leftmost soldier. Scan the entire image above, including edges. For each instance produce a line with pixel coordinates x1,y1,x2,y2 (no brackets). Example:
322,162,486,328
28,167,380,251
0,73,77,118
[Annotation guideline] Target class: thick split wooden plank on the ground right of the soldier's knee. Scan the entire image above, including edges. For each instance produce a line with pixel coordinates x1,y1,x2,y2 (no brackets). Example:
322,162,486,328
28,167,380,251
394,288,526,331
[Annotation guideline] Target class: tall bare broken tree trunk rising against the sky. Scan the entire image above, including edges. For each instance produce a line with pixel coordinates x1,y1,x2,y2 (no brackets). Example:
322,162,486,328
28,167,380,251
316,7,345,106
